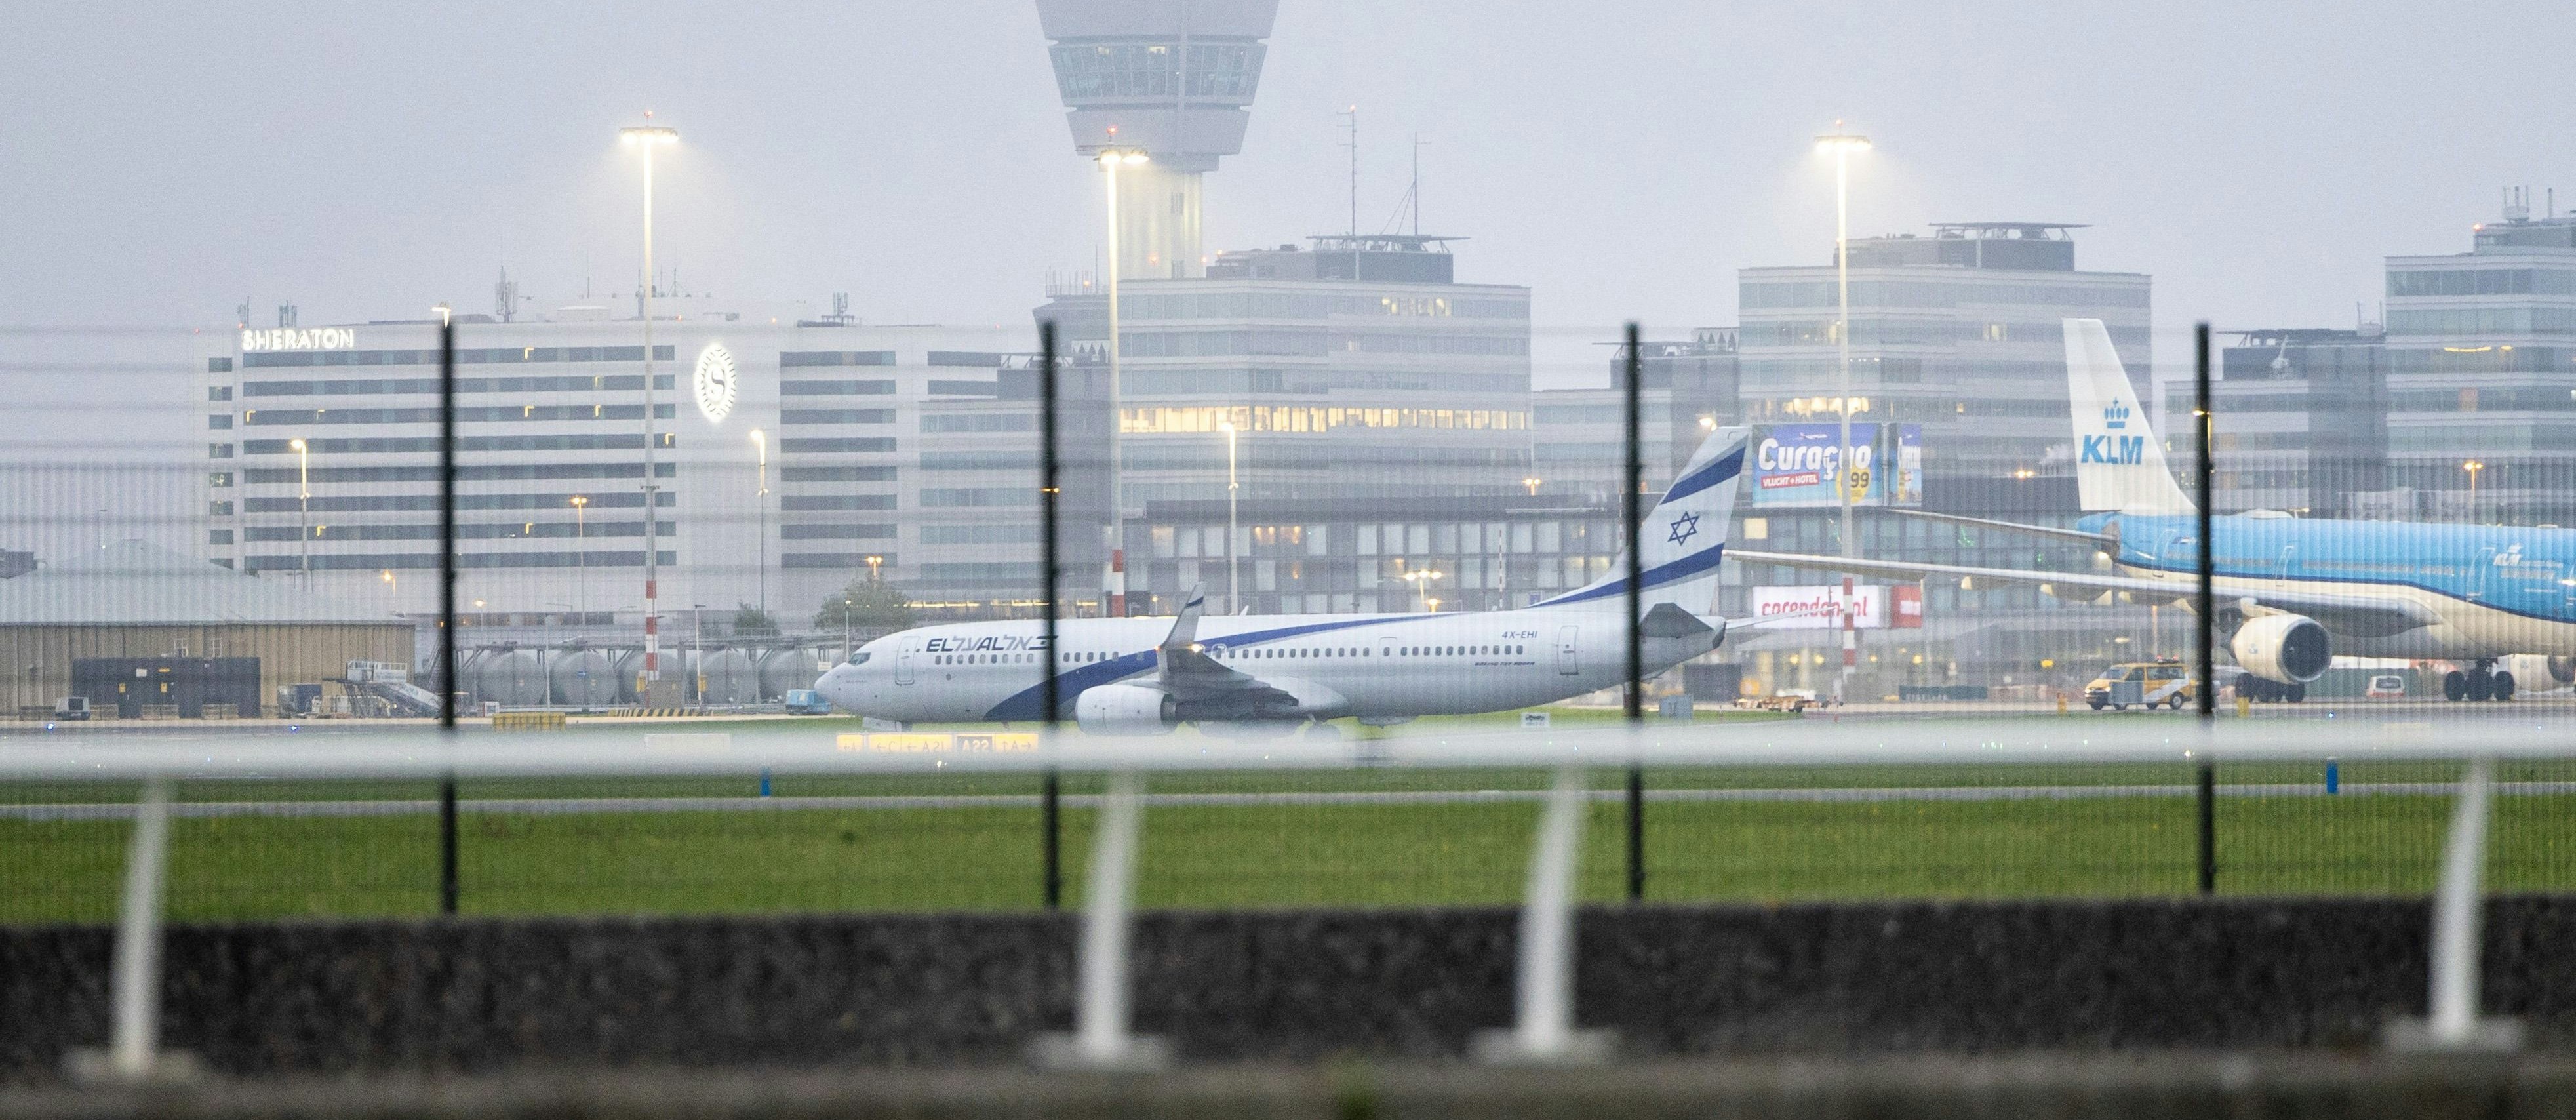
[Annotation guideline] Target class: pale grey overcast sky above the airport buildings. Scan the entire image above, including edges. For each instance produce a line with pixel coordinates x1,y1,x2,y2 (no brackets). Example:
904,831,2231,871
0,0,2576,381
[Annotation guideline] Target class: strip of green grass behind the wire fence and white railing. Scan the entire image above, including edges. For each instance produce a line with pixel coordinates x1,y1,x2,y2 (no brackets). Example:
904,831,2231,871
0,765,2576,922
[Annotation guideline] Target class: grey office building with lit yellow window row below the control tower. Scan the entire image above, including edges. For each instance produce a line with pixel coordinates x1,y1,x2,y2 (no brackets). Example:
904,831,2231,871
1035,234,1530,515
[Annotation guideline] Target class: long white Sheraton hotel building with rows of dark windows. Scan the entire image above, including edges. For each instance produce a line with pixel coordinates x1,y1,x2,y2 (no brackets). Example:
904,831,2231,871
199,309,1105,630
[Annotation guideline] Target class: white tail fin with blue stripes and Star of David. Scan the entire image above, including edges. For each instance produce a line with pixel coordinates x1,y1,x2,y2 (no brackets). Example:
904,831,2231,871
1541,428,1749,615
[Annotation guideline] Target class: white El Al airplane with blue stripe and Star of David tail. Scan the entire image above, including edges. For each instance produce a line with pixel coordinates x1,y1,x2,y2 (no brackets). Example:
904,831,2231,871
814,428,1744,734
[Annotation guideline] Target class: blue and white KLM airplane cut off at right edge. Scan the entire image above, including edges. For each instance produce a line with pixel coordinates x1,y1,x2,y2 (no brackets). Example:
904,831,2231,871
1734,319,2576,700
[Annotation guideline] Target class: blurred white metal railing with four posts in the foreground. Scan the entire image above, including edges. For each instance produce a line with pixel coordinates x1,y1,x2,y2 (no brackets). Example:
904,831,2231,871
15,718,2576,1079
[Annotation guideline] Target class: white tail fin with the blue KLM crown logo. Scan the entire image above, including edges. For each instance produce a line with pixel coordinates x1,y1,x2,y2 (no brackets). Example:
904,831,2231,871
2066,319,2195,515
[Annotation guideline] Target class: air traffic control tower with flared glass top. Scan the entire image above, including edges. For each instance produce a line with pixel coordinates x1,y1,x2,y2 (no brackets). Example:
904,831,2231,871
1038,0,1278,281
